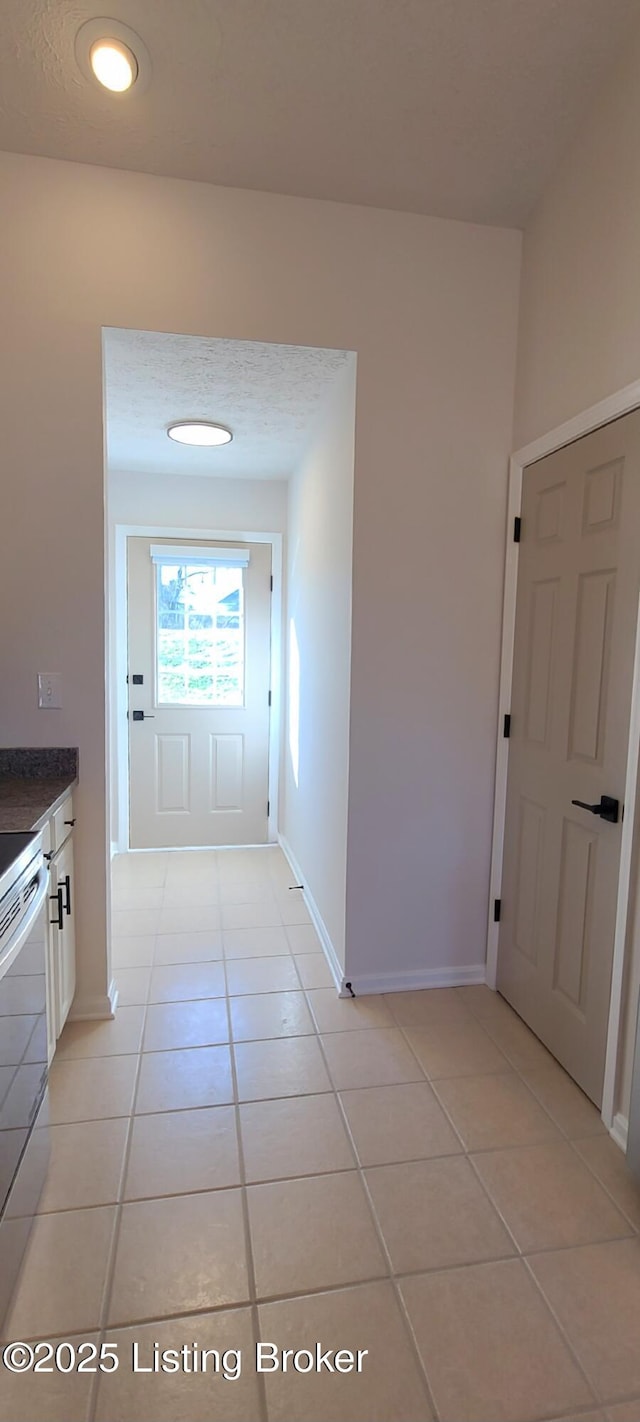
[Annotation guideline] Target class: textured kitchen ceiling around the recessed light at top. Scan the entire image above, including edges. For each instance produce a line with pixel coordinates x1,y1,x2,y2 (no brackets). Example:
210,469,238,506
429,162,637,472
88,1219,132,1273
0,0,640,226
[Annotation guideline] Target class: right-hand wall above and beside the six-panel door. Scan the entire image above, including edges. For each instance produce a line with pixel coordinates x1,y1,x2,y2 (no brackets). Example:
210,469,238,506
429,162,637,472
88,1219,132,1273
515,25,640,1115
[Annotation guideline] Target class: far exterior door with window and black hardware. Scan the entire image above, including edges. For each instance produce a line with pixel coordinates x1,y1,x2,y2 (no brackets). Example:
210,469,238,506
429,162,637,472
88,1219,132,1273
128,538,272,849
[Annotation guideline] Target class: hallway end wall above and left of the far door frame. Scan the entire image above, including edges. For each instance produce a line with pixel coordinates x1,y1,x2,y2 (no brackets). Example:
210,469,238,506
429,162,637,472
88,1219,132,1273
107,471,287,849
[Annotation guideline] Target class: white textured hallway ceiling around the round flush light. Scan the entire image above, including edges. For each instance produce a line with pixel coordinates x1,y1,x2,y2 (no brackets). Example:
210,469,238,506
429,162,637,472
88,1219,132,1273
105,330,355,479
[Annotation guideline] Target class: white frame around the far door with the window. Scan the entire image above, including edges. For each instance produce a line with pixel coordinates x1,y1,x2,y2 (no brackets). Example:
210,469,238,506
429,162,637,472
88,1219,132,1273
108,523,284,853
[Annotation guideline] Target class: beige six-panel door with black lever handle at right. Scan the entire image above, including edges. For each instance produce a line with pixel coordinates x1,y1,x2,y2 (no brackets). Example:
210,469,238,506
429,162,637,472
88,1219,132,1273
498,411,640,1105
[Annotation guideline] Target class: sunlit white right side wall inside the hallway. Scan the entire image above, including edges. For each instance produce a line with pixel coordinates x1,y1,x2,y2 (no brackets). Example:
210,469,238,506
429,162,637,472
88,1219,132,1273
282,357,356,968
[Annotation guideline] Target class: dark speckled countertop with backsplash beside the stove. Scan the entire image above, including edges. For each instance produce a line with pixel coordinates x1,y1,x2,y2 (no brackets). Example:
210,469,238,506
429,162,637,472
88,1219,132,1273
0,747,78,833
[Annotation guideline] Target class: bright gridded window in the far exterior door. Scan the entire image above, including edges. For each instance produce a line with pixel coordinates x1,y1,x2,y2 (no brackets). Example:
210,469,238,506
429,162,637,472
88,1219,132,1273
156,563,245,707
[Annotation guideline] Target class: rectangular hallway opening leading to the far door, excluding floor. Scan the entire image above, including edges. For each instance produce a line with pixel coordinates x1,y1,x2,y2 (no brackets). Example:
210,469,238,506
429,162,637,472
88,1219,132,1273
104,330,356,995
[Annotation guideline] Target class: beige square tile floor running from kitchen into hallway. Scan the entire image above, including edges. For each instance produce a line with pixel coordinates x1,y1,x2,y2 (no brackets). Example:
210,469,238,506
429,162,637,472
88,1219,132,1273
0,849,640,1422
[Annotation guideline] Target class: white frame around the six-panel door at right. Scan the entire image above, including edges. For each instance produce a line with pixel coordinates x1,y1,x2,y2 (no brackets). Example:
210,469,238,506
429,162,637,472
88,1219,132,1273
486,381,640,1131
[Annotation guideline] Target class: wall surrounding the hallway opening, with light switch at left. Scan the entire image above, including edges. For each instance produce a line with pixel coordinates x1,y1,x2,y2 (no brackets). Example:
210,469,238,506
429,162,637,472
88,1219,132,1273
0,154,521,1003
